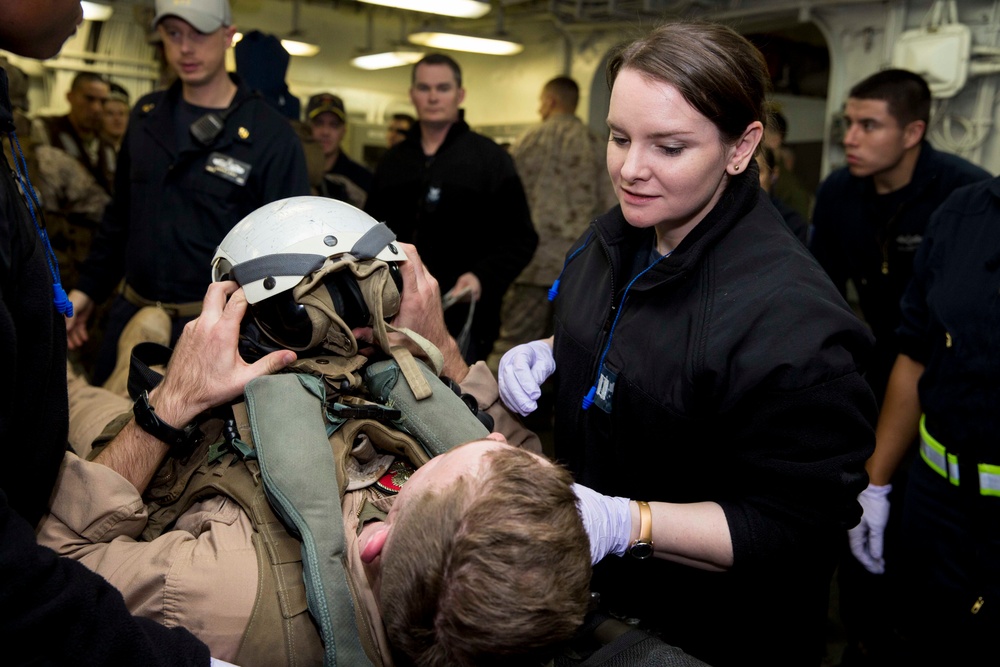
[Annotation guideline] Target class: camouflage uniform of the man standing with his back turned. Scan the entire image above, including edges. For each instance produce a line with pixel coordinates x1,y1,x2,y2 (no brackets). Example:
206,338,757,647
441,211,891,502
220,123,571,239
490,113,617,369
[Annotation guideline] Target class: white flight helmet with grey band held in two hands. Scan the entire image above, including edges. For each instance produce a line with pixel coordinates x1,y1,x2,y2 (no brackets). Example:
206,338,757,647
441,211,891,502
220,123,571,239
212,197,406,356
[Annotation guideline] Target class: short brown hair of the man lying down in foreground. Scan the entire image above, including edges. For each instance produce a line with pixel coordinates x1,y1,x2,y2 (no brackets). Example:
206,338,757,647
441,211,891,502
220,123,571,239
380,447,590,667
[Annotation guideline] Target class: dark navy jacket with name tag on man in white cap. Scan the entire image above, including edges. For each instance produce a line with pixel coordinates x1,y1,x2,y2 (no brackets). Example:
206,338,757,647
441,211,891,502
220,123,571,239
78,75,309,303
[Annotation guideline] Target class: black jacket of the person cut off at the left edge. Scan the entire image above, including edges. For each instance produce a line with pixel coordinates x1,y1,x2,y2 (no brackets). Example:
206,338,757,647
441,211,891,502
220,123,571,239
0,68,209,666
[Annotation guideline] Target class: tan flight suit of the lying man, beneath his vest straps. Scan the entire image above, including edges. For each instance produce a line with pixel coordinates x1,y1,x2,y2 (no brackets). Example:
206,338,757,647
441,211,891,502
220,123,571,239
38,362,541,667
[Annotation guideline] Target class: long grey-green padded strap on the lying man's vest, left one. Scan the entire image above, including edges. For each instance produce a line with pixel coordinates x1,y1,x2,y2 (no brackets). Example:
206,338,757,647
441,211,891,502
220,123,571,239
244,374,371,667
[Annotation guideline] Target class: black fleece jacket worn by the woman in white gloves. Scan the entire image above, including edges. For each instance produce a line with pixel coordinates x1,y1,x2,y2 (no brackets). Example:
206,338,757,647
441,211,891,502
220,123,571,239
555,163,876,667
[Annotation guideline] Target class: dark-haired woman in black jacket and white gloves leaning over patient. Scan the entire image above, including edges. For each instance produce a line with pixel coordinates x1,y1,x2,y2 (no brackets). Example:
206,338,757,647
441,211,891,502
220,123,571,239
499,22,876,667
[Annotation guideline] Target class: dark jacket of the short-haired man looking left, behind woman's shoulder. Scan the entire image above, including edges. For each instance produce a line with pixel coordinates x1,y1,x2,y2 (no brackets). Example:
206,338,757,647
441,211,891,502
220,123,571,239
809,141,990,401
